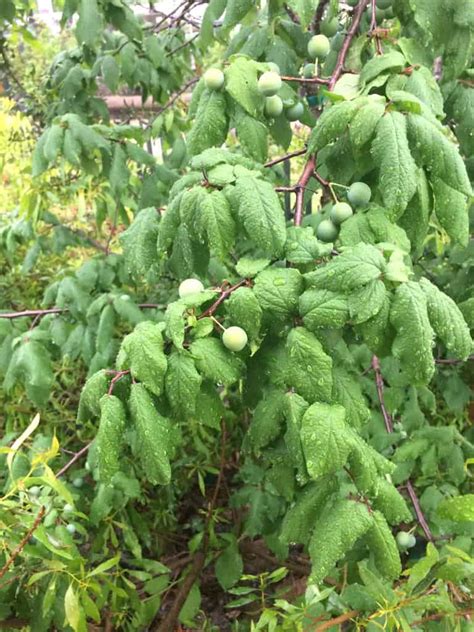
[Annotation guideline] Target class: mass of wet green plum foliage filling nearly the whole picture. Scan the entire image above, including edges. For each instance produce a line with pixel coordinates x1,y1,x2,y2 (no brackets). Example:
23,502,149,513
0,0,474,631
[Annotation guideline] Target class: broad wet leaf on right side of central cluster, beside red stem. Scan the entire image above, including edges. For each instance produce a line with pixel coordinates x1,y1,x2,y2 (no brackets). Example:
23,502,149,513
232,176,286,256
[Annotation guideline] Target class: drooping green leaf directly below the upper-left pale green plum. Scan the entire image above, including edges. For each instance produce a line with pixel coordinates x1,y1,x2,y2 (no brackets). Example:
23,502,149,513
187,88,229,156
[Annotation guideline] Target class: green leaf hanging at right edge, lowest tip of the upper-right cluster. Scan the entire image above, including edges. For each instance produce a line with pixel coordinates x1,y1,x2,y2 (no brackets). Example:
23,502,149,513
431,178,469,246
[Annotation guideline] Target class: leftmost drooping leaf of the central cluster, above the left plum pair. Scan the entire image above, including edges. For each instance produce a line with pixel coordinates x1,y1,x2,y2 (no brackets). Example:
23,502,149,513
120,208,160,276
